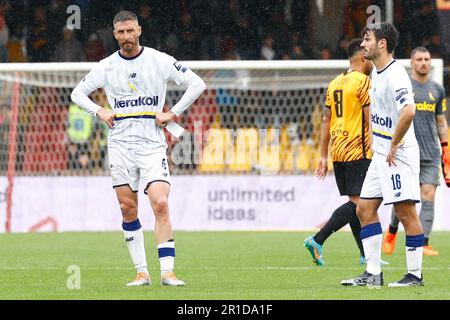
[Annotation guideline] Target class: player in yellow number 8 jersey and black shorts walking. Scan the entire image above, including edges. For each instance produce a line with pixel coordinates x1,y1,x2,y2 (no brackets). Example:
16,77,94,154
304,39,373,266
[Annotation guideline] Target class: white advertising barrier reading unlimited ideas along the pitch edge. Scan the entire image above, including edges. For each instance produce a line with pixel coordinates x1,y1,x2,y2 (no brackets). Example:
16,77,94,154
0,176,450,232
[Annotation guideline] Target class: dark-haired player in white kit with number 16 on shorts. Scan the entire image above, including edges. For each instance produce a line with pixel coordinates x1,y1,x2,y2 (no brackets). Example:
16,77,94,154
341,22,424,287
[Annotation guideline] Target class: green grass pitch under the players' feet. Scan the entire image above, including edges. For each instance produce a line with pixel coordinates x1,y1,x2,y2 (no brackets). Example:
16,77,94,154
0,232,450,300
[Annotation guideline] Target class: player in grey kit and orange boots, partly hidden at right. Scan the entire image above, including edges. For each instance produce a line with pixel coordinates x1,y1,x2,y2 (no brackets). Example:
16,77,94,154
383,47,450,256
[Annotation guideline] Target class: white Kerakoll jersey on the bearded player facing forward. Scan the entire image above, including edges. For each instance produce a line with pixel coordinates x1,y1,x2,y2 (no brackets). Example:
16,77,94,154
74,47,199,149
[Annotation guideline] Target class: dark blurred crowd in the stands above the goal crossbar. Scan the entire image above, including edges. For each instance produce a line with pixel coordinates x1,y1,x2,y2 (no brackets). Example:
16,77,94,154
0,0,449,62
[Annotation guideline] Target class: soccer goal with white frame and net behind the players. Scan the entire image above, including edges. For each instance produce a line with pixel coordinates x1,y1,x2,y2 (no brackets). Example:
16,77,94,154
0,59,443,231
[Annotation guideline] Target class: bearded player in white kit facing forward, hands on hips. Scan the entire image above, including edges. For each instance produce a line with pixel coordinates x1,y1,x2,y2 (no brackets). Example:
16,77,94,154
71,11,206,286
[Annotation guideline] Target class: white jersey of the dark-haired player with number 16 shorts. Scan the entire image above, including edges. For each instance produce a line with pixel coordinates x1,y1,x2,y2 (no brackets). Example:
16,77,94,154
370,60,419,162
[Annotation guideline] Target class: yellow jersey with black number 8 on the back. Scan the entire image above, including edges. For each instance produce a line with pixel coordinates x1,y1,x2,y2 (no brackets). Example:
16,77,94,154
325,71,372,162
